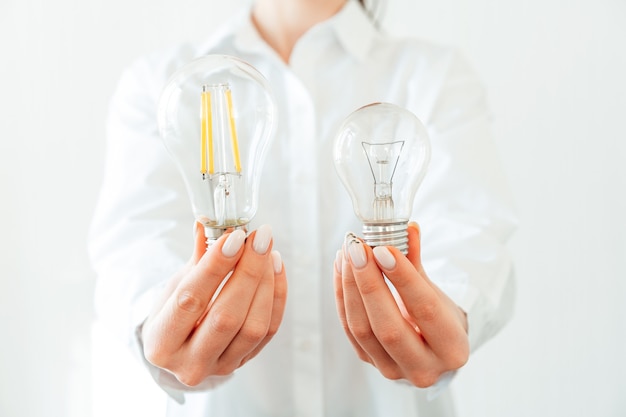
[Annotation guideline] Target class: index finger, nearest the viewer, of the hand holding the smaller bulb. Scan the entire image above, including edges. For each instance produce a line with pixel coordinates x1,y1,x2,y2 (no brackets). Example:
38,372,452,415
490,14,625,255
374,247,467,364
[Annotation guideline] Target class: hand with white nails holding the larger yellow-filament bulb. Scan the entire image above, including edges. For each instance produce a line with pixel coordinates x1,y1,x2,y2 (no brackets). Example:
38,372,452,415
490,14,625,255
142,224,287,386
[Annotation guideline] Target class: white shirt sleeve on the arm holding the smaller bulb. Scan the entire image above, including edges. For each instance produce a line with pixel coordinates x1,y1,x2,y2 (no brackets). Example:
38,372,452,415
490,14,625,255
414,52,517,351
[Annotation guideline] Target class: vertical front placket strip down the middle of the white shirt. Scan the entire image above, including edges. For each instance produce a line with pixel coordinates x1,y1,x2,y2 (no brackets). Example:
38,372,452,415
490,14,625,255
286,72,324,417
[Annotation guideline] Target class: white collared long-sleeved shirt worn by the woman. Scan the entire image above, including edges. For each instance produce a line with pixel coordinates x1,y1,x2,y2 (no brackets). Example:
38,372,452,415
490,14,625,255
90,0,515,417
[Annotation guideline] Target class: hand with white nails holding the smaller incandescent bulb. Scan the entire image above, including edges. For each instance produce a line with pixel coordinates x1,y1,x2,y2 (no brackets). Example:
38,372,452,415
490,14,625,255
334,223,469,387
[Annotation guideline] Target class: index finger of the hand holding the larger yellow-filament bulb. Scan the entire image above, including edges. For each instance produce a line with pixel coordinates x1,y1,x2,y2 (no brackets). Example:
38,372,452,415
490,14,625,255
144,230,245,358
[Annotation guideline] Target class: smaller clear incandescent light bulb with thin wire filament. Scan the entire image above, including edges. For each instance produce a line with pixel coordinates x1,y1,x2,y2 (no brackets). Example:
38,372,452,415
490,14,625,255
333,103,430,254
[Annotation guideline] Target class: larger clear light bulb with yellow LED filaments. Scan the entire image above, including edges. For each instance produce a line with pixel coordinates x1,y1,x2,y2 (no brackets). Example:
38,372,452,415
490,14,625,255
158,55,276,245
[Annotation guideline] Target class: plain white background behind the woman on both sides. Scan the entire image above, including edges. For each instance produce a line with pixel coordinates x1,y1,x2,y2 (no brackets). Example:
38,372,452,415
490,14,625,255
0,0,626,417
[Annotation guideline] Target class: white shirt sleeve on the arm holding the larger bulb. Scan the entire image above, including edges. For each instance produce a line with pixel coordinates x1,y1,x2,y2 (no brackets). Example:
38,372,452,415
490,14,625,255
88,55,229,402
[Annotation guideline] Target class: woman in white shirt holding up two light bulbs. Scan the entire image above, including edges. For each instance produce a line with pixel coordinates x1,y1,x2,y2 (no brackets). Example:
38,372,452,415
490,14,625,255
91,0,514,416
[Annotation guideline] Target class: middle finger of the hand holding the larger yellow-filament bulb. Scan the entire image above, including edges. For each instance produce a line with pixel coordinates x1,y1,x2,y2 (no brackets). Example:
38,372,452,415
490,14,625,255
190,226,273,362
